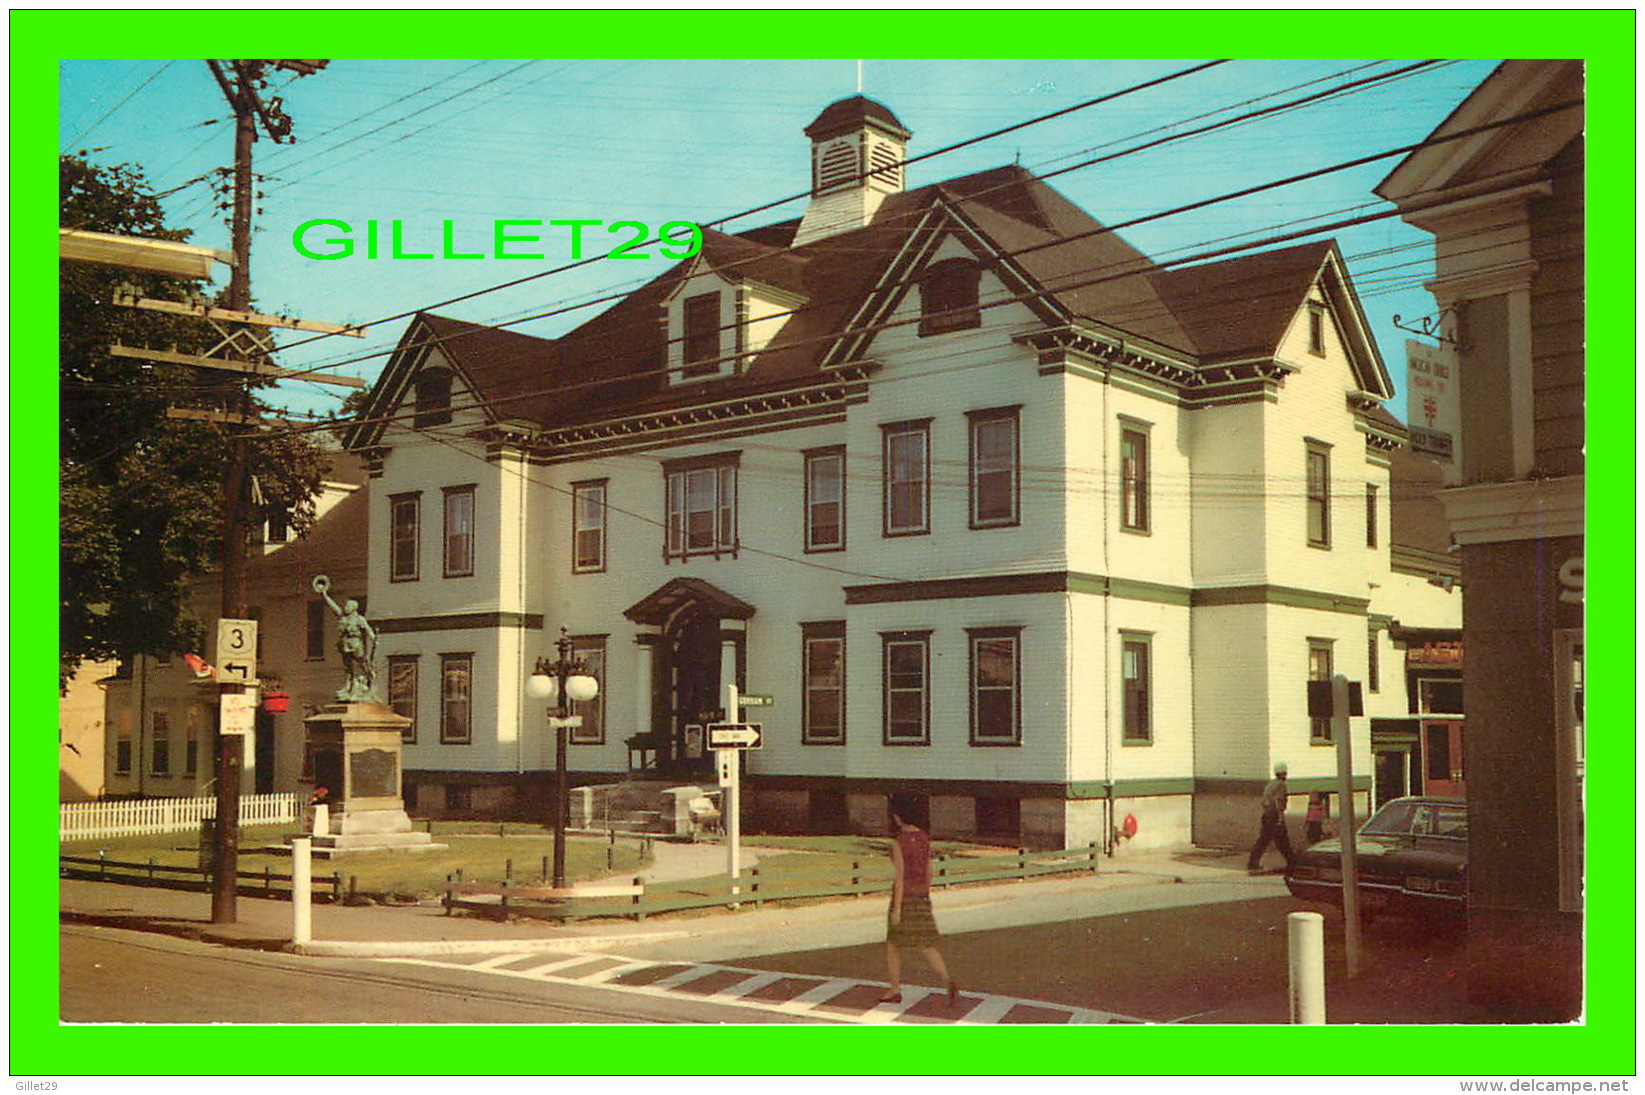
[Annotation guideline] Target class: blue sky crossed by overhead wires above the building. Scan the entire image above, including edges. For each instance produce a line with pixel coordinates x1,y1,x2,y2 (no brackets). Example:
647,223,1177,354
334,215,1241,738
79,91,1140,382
59,59,1494,418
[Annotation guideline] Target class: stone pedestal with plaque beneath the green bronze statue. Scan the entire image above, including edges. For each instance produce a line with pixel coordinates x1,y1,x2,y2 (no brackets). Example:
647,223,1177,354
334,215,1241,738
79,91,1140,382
303,702,446,858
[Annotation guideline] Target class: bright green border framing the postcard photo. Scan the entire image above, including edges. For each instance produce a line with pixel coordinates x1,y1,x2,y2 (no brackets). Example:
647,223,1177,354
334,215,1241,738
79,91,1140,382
10,10,1637,1077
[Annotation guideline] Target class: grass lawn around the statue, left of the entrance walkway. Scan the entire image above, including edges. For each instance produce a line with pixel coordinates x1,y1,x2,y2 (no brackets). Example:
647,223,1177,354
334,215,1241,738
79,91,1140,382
61,822,650,898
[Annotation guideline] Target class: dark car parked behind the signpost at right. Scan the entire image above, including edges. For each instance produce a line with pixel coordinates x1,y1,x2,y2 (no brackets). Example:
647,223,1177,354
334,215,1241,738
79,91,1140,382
1286,796,1467,917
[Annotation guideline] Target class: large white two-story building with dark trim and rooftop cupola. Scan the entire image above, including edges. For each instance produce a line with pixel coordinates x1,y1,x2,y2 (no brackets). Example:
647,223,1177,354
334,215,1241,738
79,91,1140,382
349,97,1459,845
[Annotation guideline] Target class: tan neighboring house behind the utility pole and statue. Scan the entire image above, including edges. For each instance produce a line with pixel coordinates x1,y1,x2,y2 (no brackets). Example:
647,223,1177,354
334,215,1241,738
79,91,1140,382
102,454,370,797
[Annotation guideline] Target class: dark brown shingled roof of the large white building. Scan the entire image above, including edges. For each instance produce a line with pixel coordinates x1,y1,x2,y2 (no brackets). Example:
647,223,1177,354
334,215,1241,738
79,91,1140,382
363,161,1374,444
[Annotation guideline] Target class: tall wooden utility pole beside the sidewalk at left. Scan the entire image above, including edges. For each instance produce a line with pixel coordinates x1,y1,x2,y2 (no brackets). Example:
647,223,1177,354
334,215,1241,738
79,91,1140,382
206,61,326,924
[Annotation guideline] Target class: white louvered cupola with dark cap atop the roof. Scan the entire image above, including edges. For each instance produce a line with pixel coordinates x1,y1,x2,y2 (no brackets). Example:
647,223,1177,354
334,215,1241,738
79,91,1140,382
795,95,911,247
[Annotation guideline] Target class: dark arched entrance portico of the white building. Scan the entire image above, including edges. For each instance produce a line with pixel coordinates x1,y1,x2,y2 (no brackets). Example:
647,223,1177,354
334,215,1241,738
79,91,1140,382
623,577,753,779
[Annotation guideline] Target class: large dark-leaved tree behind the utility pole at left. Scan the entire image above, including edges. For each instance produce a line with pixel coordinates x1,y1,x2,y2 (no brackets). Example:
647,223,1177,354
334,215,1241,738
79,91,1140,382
58,156,327,684
